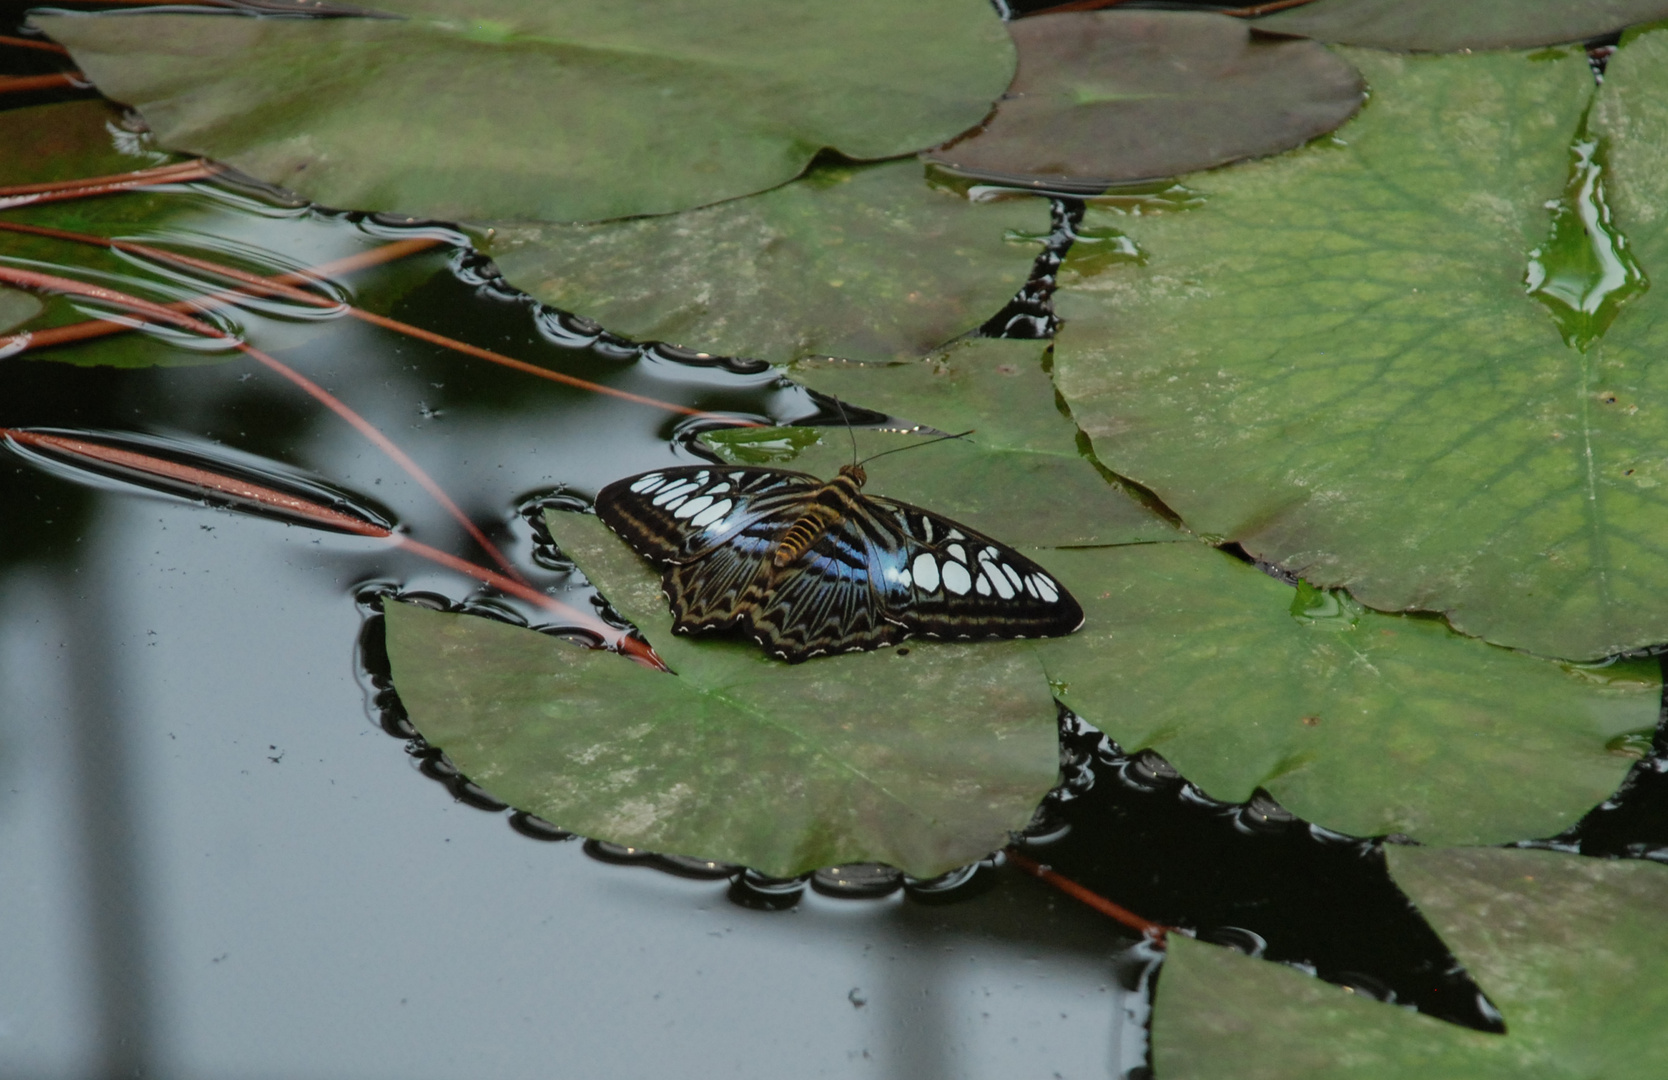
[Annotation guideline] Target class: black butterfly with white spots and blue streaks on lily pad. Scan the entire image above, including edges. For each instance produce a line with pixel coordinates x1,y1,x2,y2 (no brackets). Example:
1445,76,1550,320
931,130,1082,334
597,464,1083,663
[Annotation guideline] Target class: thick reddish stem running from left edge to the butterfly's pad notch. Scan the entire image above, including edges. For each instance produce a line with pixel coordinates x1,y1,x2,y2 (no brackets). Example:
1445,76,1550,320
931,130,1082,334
0,427,666,671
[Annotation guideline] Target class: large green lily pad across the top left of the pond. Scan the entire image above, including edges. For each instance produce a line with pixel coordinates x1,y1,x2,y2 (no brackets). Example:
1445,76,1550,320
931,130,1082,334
35,0,1014,220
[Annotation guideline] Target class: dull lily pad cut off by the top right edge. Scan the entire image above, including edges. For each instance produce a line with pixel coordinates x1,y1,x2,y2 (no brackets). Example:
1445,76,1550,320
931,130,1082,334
1253,0,1668,52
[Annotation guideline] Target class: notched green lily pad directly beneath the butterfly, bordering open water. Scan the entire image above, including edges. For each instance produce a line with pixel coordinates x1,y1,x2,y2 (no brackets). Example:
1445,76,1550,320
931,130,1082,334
387,512,1058,876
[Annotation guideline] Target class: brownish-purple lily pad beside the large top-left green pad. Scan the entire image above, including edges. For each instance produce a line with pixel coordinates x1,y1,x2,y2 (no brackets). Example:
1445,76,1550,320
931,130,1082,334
927,10,1366,192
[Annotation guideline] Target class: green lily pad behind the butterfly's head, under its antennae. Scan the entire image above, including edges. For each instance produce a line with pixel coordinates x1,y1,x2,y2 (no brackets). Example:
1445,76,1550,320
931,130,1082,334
706,339,1179,546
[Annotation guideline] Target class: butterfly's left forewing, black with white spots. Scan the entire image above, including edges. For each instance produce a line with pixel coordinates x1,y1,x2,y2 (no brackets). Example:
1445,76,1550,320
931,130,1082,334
597,466,822,563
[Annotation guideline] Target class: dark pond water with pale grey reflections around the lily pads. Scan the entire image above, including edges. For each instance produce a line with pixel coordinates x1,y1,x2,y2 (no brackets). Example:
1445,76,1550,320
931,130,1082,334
0,23,1668,1080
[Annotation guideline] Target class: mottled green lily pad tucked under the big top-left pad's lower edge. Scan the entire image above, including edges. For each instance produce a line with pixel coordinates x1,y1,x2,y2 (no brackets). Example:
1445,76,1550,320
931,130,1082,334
484,160,1049,364
